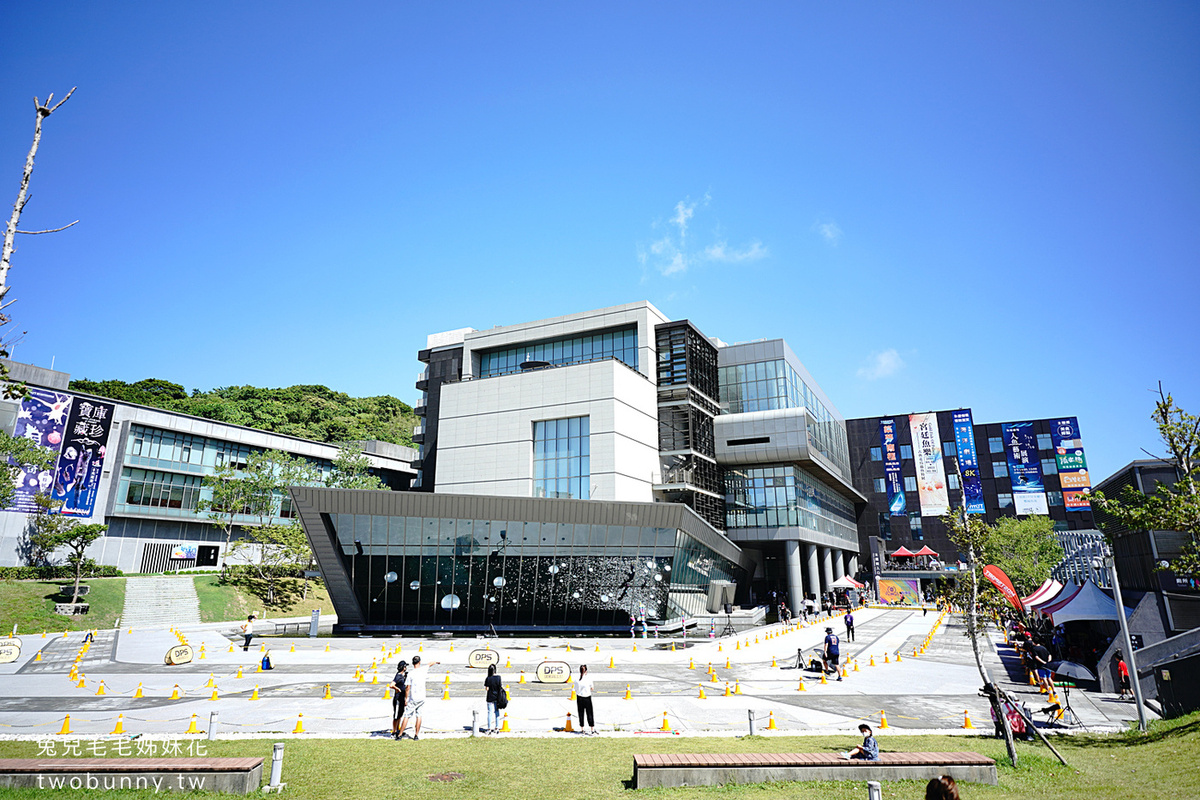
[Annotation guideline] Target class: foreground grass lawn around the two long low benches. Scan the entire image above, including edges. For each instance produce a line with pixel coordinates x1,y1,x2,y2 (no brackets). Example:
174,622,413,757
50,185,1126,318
0,714,1200,800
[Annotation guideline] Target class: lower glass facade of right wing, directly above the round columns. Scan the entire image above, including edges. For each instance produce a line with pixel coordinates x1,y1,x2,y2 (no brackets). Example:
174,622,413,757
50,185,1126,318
725,465,858,542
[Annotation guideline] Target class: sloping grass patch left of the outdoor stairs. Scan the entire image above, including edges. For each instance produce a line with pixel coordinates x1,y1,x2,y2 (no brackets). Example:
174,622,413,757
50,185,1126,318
0,578,125,633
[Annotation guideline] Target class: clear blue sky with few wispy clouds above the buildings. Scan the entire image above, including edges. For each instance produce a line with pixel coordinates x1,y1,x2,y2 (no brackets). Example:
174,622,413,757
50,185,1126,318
0,2,1200,479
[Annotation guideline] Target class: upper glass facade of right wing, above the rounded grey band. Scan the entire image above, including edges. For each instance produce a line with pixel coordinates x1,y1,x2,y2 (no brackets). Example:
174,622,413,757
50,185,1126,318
720,360,850,474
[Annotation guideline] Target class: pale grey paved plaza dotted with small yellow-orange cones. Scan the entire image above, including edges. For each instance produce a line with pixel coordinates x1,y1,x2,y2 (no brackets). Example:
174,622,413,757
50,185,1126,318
0,608,1134,738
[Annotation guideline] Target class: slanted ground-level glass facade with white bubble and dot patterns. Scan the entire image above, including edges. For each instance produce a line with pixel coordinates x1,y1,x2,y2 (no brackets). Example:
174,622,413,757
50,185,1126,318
328,513,739,630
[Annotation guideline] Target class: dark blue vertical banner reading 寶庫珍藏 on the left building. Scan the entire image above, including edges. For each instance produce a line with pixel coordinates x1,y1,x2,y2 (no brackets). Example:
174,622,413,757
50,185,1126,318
53,398,114,517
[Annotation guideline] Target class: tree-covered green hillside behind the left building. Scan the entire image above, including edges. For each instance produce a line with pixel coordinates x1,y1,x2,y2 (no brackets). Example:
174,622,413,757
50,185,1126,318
70,378,416,446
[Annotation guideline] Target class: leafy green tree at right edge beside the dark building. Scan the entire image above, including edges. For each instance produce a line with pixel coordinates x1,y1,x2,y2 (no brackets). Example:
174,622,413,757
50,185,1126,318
1091,383,1200,577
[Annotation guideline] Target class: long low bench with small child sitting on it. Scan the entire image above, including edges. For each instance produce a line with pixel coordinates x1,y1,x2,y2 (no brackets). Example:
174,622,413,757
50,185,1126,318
634,752,998,789
